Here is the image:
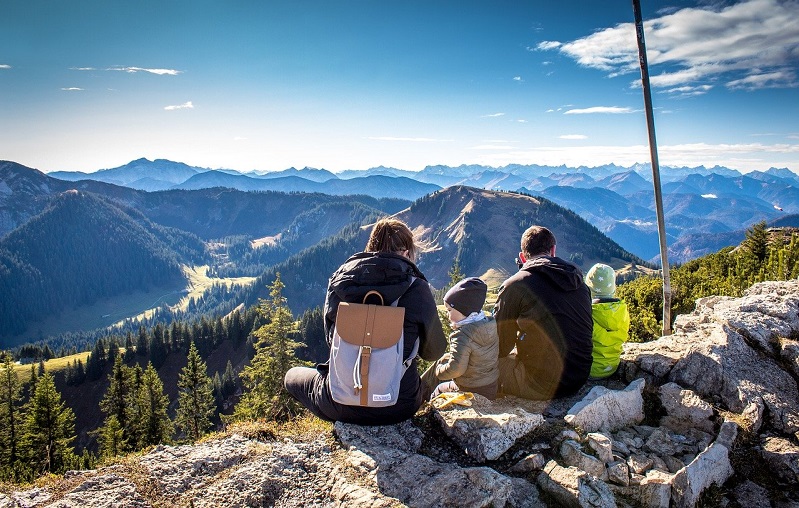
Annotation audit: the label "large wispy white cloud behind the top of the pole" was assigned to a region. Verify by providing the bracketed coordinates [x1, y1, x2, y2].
[536, 0, 799, 93]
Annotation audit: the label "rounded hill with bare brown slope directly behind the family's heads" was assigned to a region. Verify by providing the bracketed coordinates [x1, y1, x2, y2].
[231, 186, 647, 313]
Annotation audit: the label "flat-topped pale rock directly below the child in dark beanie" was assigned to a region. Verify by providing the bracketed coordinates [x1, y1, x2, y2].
[435, 394, 544, 462]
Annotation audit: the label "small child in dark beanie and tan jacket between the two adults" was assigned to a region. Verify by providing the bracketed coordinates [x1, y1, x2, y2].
[422, 277, 499, 400]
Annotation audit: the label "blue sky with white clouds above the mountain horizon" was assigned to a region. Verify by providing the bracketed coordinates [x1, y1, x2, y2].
[0, 0, 799, 172]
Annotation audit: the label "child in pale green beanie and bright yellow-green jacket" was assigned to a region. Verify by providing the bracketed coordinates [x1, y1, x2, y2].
[585, 263, 630, 379]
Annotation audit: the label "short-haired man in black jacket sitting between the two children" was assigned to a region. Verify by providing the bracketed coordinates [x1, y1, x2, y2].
[494, 226, 593, 400]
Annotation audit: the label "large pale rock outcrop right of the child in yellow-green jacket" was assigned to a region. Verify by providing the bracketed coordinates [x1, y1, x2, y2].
[622, 280, 799, 434]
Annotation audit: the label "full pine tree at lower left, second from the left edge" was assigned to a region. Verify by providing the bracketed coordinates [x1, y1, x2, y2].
[22, 372, 75, 473]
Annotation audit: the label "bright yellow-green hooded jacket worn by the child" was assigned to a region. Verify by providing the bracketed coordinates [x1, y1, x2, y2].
[591, 298, 630, 378]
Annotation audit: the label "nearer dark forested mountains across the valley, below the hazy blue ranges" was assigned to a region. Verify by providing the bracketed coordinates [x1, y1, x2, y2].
[0, 162, 645, 342]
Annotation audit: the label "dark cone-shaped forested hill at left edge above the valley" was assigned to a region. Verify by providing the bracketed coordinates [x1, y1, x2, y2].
[0, 190, 207, 334]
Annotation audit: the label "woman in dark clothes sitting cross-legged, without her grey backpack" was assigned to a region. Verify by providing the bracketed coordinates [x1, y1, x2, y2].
[284, 219, 447, 425]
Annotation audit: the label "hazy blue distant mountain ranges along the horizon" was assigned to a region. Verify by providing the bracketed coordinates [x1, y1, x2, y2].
[43, 159, 799, 263]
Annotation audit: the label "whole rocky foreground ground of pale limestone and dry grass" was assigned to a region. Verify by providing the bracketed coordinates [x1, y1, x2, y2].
[0, 280, 799, 508]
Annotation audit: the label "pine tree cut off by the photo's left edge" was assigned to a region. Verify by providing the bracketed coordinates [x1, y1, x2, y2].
[0, 354, 22, 480]
